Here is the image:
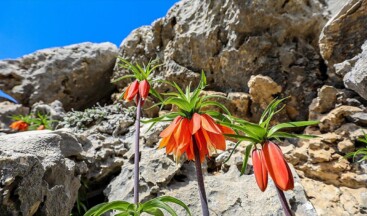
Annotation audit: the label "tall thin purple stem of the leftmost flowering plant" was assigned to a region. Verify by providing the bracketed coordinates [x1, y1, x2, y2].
[134, 94, 141, 204]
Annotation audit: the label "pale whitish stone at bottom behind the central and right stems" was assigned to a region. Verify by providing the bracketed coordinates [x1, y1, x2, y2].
[162, 164, 316, 216]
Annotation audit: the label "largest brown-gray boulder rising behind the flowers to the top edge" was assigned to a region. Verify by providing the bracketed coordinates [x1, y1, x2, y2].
[114, 0, 326, 120]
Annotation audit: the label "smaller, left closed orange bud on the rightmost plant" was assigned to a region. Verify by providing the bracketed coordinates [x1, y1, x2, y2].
[252, 149, 268, 192]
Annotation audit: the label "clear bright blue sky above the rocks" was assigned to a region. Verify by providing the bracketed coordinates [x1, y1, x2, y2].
[0, 0, 178, 59]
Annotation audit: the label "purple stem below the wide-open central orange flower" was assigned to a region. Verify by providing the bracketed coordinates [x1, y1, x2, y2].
[192, 137, 209, 216]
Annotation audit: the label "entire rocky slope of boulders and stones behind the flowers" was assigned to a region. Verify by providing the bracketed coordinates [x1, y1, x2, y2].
[0, 0, 367, 216]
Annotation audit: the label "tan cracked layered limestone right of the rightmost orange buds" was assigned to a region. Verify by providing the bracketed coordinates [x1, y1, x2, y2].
[286, 130, 367, 189]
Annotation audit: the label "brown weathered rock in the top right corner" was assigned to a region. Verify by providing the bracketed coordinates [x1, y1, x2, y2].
[319, 0, 367, 81]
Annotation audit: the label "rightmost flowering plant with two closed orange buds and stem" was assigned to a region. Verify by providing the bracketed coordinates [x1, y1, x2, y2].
[222, 98, 318, 216]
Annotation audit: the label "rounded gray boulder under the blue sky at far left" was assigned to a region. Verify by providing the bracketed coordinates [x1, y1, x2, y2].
[0, 43, 118, 110]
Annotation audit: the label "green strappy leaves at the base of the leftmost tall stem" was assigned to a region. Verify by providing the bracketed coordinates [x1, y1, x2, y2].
[84, 196, 191, 216]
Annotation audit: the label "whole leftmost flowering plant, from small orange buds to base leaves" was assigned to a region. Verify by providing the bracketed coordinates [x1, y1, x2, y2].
[84, 58, 191, 216]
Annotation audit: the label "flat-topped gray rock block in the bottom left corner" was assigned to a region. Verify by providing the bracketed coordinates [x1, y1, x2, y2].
[0, 131, 83, 216]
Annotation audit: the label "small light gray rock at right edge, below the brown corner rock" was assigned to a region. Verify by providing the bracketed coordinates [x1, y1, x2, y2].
[343, 41, 367, 100]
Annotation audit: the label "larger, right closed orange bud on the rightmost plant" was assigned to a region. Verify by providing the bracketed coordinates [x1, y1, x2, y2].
[263, 141, 294, 191]
